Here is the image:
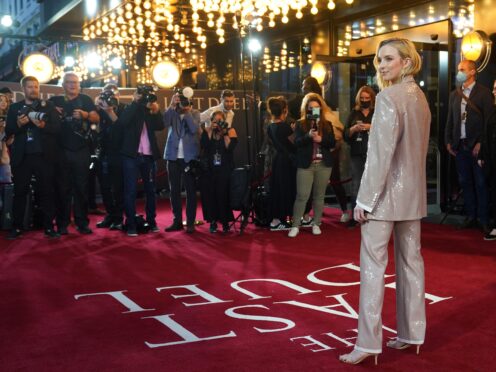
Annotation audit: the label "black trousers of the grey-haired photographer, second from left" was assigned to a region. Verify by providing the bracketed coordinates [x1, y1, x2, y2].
[56, 147, 90, 228]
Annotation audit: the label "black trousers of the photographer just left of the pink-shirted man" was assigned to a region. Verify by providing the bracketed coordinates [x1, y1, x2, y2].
[97, 155, 124, 223]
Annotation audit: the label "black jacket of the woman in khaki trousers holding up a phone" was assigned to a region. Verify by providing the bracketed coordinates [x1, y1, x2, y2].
[295, 121, 336, 168]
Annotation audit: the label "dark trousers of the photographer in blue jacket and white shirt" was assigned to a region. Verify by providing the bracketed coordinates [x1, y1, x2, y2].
[167, 159, 196, 225]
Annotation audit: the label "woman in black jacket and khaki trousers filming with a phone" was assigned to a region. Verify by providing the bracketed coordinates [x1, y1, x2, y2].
[288, 93, 336, 238]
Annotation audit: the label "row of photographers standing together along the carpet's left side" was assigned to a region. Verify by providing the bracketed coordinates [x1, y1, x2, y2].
[0, 72, 237, 240]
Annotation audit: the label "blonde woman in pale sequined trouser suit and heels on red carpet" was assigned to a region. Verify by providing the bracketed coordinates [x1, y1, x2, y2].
[340, 38, 431, 364]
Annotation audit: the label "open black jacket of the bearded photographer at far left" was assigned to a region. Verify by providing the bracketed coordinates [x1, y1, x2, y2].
[5, 100, 60, 168]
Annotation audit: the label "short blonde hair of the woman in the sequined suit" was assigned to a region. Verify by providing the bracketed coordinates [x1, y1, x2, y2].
[374, 38, 422, 89]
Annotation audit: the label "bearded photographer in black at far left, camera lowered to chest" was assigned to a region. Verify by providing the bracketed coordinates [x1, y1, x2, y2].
[5, 76, 60, 239]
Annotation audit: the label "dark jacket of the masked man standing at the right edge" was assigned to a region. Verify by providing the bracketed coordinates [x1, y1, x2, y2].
[445, 83, 493, 150]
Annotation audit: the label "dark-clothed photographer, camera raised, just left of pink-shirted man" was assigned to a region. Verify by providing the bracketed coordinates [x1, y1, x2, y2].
[96, 84, 125, 230]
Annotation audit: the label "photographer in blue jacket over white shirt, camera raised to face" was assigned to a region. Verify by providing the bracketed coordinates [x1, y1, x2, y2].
[164, 91, 200, 234]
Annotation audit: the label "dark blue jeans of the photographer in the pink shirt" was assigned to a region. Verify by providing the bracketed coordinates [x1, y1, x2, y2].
[122, 155, 157, 229]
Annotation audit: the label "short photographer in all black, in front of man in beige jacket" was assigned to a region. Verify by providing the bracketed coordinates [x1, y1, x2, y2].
[200, 111, 238, 233]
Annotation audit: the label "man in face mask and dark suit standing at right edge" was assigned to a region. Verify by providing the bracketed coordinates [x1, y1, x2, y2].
[445, 60, 493, 233]
